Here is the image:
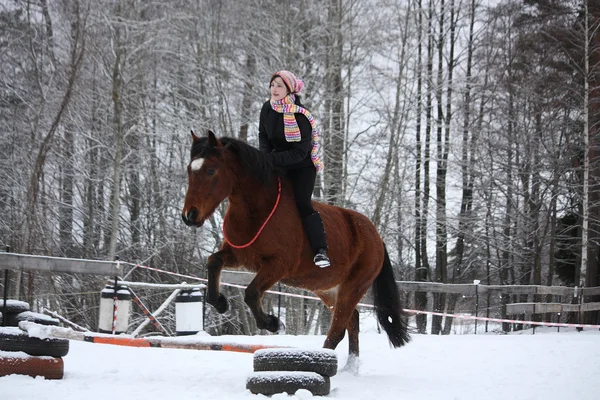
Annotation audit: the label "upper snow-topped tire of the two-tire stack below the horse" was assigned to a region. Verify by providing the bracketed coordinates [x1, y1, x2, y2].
[254, 349, 338, 377]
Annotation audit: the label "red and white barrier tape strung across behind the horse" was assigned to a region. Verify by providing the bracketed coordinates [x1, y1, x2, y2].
[122, 262, 600, 329]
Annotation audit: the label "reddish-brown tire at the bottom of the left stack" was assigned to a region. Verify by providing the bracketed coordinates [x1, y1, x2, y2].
[0, 355, 65, 379]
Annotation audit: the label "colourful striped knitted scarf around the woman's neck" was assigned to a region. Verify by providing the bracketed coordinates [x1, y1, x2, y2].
[271, 94, 323, 171]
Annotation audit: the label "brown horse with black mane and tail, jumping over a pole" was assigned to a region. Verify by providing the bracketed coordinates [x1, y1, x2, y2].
[182, 131, 409, 357]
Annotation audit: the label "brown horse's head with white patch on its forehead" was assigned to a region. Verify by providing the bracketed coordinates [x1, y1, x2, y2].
[181, 131, 233, 227]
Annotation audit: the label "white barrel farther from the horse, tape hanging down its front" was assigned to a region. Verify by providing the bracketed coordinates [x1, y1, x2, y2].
[98, 285, 131, 334]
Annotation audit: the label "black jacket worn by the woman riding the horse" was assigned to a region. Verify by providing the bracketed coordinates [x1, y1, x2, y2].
[258, 99, 313, 169]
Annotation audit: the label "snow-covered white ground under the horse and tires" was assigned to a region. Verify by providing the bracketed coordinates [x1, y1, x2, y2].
[0, 328, 600, 400]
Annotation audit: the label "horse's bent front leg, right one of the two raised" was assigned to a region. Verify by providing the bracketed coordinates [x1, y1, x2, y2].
[244, 268, 284, 332]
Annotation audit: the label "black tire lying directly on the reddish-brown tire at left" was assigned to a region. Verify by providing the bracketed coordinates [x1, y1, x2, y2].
[0, 328, 69, 357]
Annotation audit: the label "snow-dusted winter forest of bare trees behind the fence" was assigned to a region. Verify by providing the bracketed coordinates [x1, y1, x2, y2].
[0, 0, 600, 333]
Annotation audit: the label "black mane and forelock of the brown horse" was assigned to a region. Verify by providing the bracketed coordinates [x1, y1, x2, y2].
[191, 137, 281, 184]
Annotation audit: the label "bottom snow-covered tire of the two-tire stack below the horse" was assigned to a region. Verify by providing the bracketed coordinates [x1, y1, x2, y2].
[246, 371, 331, 396]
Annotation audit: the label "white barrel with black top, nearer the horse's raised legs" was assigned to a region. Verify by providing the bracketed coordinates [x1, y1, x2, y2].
[175, 288, 204, 336]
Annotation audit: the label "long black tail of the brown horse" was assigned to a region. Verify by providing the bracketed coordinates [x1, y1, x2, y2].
[372, 245, 410, 347]
